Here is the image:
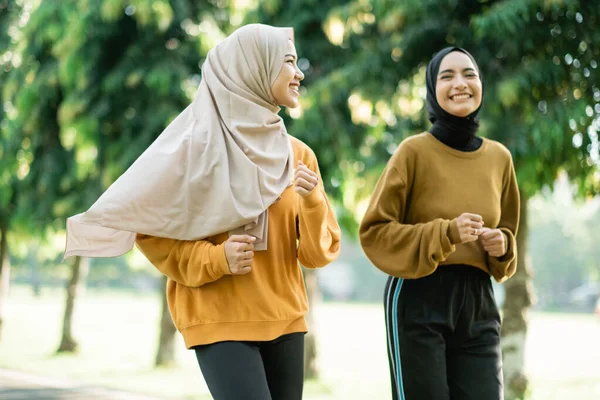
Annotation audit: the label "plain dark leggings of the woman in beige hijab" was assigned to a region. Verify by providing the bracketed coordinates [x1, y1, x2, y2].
[194, 333, 304, 400]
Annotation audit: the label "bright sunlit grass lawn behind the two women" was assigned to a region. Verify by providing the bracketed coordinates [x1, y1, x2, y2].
[0, 288, 600, 400]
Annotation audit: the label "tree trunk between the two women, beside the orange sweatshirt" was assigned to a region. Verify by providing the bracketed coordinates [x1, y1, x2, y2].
[304, 268, 321, 379]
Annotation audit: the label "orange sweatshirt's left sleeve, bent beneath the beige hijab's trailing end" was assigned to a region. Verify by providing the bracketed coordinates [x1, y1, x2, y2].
[136, 234, 231, 287]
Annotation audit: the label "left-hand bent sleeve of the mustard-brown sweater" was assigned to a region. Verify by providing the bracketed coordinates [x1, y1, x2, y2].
[359, 144, 460, 279]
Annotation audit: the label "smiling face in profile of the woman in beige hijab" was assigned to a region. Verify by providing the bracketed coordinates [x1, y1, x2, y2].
[271, 40, 304, 108]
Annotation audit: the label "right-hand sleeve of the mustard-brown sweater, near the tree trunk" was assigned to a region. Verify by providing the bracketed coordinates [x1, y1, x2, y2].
[487, 155, 520, 282]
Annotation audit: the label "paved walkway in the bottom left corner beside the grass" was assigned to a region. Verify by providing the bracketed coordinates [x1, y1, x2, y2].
[0, 369, 160, 400]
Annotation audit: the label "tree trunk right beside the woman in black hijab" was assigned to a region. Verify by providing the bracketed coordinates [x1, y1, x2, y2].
[501, 191, 534, 400]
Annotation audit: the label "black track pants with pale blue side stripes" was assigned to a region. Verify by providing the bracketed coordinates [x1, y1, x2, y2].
[385, 265, 503, 400]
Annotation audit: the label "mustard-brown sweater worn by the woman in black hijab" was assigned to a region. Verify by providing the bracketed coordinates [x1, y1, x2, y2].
[360, 132, 519, 282]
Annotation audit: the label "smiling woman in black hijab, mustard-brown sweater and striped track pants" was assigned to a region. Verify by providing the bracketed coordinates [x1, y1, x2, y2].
[360, 47, 519, 400]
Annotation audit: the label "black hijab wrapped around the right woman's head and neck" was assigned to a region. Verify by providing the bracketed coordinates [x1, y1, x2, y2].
[426, 47, 483, 151]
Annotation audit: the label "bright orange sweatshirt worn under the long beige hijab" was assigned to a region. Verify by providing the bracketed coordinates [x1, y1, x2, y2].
[136, 137, 341, 348]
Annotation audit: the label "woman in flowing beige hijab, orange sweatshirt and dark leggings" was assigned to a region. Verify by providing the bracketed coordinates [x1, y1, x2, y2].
[65, 24, 340, 400]
